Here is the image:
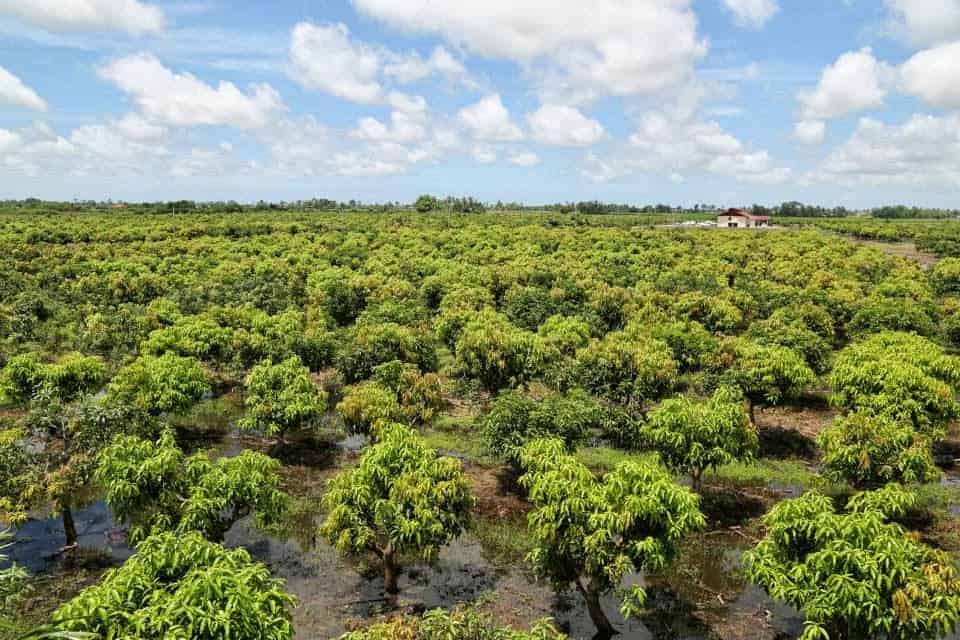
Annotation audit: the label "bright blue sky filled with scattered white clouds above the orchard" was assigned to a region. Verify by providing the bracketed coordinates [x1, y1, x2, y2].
[0, 0, 960, 208]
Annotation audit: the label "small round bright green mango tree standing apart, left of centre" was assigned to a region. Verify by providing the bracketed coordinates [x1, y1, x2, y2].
[240, 356, 327, 438]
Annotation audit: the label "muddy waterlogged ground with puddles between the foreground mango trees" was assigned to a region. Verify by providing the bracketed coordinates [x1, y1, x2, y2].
[5, 414, 960, 640]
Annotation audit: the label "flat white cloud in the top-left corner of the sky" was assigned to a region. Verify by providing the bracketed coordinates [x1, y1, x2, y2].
[0, 0, 164, 36]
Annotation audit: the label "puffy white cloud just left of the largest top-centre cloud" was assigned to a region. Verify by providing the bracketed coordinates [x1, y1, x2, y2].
[290, 22, 383, 104]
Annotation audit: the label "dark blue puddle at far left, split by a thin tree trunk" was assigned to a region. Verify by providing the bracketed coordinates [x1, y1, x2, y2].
[5, 501, 133, 573]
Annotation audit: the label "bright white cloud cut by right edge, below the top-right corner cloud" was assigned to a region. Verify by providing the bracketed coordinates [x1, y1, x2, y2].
[900, 42, 960, 109]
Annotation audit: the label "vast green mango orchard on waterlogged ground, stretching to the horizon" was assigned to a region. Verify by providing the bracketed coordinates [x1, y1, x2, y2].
[0, 211, 960, 640]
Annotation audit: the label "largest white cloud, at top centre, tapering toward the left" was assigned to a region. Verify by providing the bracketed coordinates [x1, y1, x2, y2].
[353, 0, 707, 100]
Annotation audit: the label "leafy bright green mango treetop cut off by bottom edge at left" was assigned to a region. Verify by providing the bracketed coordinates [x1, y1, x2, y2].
[51, 532, 296, 640]
